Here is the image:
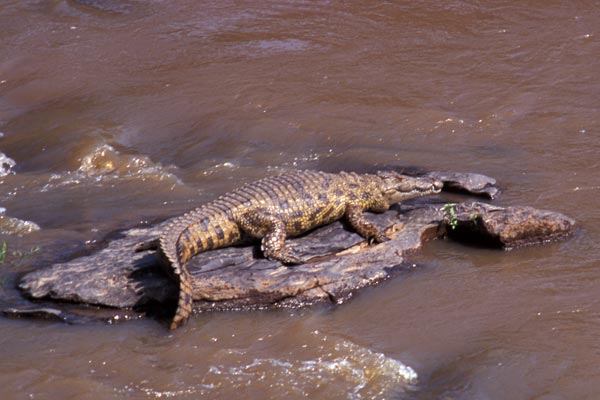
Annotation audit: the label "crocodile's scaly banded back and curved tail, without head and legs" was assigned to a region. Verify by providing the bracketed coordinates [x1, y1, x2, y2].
[160, 171, 380, 329]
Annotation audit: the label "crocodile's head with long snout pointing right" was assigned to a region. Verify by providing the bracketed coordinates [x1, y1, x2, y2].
[377, 171, 444, 204]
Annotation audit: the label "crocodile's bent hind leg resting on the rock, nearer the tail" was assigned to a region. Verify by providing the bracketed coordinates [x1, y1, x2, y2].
[236, 211, 304, 265]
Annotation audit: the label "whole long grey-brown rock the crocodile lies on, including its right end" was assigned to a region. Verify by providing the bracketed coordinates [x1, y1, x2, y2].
[11, 174, 575, 324]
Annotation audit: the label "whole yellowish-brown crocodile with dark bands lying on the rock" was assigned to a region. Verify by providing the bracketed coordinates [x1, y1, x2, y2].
[137, 170, 443, 329]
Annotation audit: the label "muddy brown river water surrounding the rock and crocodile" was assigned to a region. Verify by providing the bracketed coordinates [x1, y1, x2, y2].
[0, 0, 600, 400]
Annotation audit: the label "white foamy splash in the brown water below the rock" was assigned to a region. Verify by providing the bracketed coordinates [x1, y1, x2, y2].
[202, 340, 417, 400]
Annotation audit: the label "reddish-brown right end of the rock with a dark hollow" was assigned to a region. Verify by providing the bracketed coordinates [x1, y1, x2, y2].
[440, 203, 575, 249]
